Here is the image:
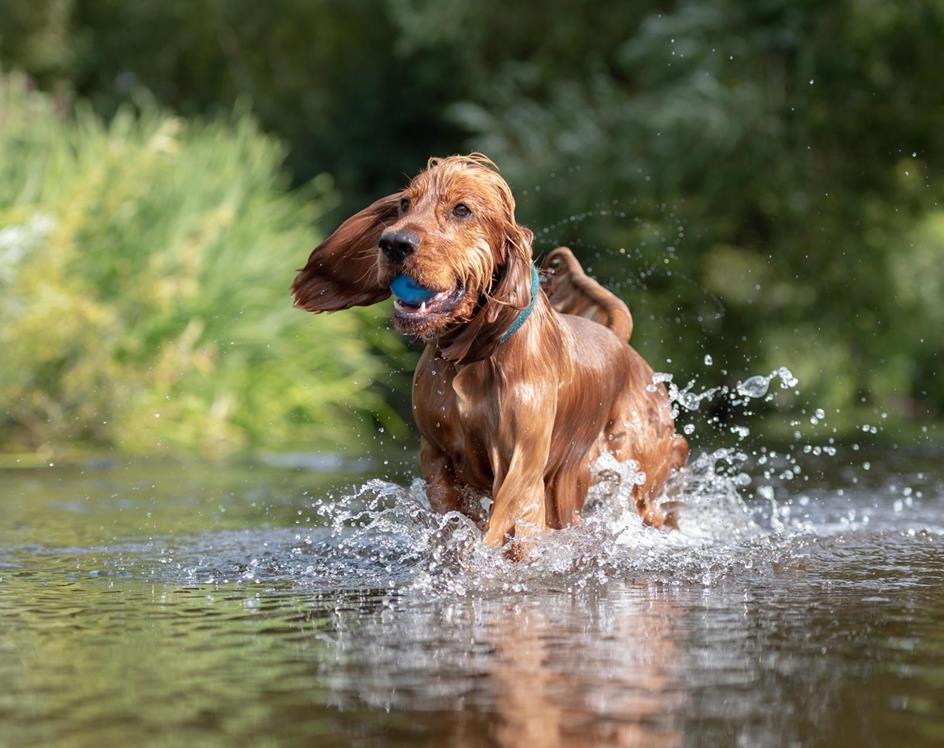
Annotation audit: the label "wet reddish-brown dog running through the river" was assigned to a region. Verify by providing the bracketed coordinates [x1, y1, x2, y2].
[292, 154, 688, 546]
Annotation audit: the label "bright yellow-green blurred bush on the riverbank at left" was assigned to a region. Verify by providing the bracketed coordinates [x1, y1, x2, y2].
[0, 76, 395, 453]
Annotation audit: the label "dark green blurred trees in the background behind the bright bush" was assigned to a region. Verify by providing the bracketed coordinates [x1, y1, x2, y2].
[0, 0, 944, 450]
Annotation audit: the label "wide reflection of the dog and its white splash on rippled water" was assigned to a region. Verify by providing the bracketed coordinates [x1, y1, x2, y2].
[320, 587, 682, 748]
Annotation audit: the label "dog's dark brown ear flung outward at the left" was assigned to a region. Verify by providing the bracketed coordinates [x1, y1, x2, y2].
[292, 193, 400, 312]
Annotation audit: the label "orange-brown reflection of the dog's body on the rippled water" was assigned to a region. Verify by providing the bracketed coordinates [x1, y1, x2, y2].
[488, 597, 680, 746]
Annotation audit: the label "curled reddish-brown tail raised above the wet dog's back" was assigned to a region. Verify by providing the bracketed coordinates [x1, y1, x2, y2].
[542, 247, 633, 343]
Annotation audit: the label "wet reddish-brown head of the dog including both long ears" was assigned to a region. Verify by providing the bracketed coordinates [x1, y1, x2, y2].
[292, 154, 532, 360]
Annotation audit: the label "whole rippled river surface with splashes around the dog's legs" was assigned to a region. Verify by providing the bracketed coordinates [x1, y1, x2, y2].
[0, 444, 944, 746]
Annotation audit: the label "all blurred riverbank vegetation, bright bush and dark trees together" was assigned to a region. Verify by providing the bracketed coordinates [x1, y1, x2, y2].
[0, 0, 944, 453]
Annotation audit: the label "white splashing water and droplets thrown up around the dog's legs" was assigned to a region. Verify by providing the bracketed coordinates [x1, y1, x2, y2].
[282, 360, 892, 595]
